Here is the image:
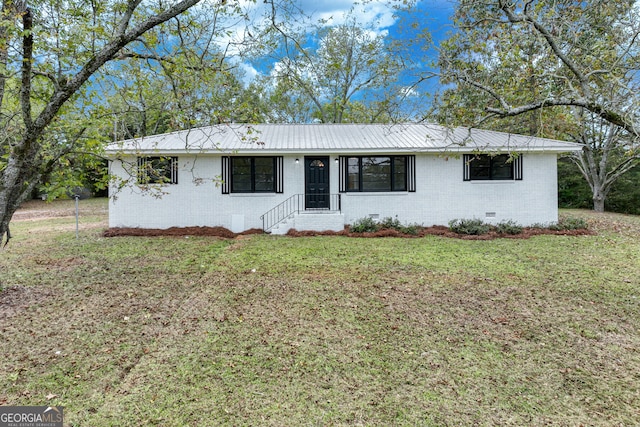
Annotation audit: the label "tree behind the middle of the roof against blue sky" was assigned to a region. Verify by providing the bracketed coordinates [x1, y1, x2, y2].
[252, 13, 405, 123]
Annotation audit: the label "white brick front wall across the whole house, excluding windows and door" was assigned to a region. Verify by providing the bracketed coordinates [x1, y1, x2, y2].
[109, 153, 558, 232]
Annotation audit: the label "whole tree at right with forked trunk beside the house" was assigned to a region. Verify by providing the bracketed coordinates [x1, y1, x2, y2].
[436, 0, 640, 210]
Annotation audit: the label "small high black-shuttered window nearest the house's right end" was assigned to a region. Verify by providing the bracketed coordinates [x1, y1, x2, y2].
[463, 154, 522, 181]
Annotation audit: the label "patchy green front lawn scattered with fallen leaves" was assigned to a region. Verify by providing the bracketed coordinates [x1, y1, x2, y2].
[0, 200, 640, 426]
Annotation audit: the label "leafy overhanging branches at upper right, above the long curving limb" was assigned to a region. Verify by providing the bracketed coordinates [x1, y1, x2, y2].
[440, 0, 640, 138]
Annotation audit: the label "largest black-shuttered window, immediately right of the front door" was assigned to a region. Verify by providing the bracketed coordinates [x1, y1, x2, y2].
[340, 156, 415, 192]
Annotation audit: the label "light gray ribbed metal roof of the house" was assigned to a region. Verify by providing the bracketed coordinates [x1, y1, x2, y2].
[107, 124, 582, 154]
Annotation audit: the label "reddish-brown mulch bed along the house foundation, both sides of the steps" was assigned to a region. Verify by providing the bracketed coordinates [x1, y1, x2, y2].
[102, 226, 595, 240]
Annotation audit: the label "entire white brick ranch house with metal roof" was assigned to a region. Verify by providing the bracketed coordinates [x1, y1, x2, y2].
[107, 124, 581, 233]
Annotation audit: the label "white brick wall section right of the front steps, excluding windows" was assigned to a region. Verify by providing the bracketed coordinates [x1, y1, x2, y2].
[342, 154, 558, 226]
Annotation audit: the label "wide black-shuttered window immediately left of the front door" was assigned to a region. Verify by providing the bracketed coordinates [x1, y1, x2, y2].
[222, 156, 282, 194]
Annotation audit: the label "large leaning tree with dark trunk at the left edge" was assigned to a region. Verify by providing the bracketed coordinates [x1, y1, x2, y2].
[0, 0, 241, 242]
